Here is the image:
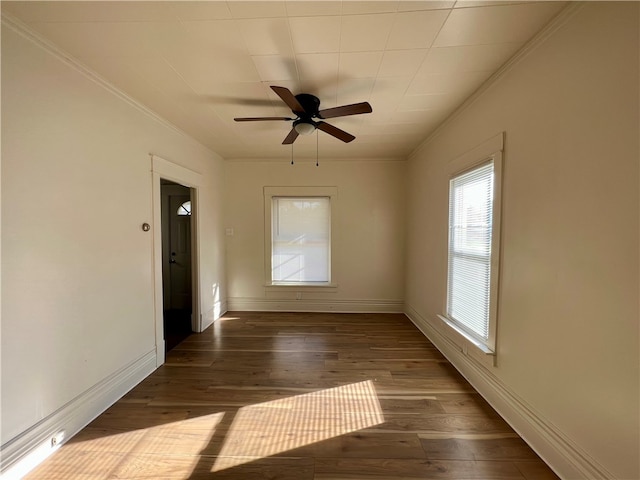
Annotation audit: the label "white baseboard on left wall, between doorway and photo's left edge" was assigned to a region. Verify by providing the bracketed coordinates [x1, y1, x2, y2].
[0, 349, 156, 480]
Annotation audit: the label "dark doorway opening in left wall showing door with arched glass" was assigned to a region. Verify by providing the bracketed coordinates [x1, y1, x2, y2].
[160, 179, 194, 353]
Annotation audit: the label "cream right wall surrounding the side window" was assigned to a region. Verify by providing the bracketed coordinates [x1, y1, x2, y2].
[406, 2, 640, 479]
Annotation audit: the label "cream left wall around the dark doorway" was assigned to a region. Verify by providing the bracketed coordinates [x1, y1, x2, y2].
[2, 20, 224, 460]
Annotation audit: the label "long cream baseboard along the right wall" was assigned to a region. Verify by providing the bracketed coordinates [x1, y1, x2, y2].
[405, 305, 615, 480]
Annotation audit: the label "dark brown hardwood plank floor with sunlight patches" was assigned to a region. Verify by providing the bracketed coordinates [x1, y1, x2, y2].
[27, 312, 558, 480]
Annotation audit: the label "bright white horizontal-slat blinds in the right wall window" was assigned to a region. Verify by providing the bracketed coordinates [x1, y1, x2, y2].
[447, 161, 494, 341]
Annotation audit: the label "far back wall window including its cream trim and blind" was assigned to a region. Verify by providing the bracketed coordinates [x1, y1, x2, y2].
[265, 187, 337, 289]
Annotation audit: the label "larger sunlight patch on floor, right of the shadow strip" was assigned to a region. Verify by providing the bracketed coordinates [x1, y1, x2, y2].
[211, 380, 384, 472]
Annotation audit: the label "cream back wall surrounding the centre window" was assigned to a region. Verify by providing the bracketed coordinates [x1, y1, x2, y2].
[225, 158, 405, 311]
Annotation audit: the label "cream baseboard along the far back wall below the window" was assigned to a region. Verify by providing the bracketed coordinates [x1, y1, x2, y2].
[227, 297, 404, 313]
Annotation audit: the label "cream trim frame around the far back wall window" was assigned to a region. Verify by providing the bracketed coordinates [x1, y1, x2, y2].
[264, 186, 338, 292]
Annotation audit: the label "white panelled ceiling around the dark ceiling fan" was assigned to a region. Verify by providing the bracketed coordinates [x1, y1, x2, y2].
[2, 0, 565, 159]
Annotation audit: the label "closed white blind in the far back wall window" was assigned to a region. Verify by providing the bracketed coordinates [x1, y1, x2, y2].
[271, 197, 331, 283]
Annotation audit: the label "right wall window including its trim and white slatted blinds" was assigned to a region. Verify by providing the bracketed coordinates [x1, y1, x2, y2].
[441, 135, 503, 355]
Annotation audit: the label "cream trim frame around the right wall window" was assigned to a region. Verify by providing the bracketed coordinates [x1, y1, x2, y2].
[438, 132, 504, 364]
